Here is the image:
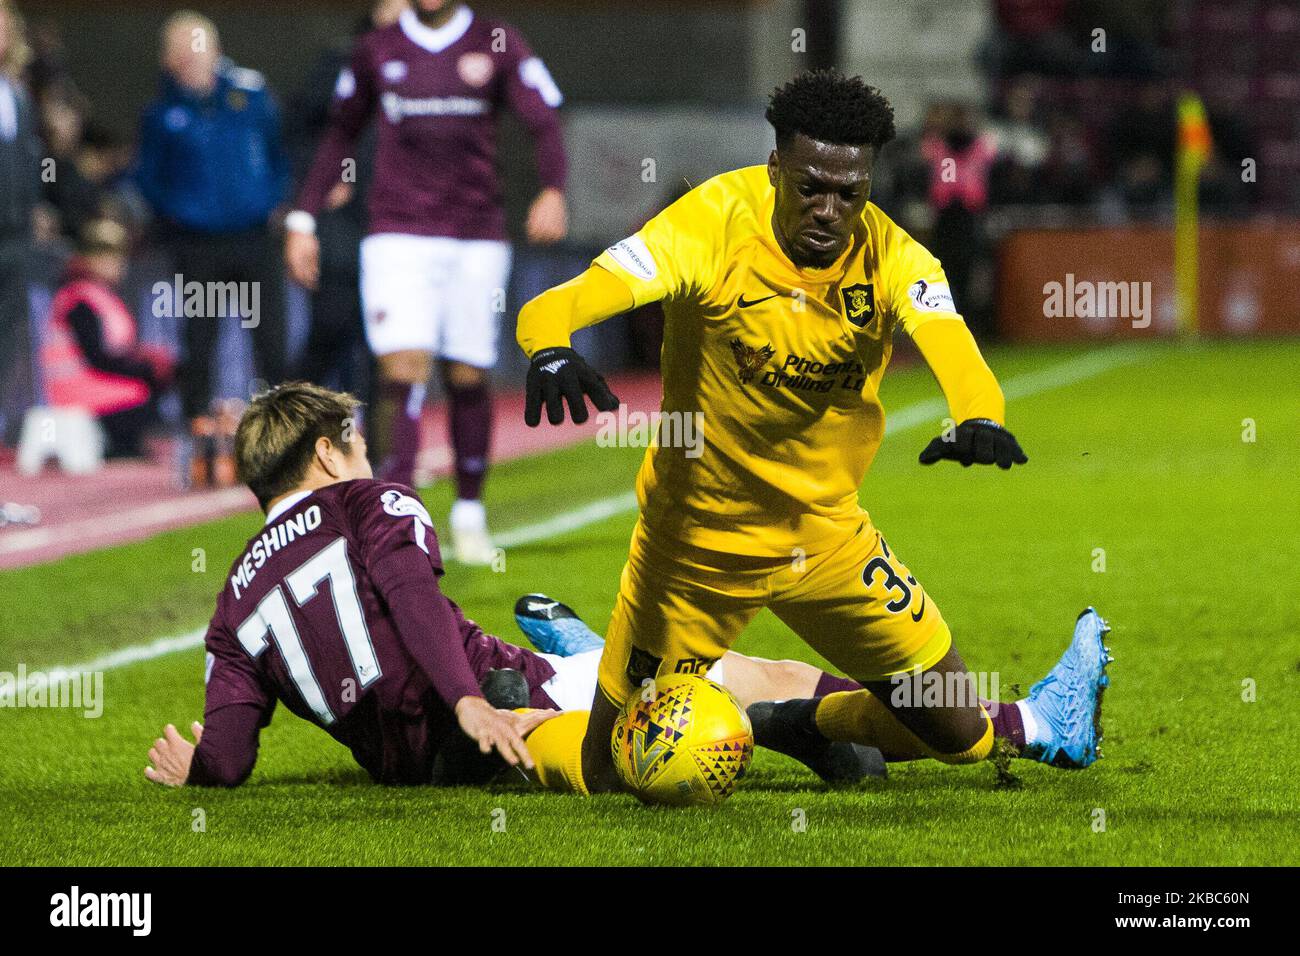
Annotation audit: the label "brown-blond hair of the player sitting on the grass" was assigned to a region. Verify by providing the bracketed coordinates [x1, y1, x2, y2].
[235, 381, 361, 507]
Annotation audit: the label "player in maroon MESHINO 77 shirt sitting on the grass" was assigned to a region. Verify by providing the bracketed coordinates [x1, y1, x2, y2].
[146, 382, 879, 790]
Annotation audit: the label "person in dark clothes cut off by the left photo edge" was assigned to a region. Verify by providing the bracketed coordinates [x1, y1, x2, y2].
[0, 0, 42, 442]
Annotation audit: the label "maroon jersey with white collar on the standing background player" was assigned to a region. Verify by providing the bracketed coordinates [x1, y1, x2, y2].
[298, 7, 566, 239]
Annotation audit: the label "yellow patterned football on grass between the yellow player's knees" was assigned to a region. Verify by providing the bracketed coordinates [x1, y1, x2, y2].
[610, 674, 754, 806]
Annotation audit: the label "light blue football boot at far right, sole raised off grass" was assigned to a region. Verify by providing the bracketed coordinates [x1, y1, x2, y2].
[1022, 607, 1114, 770]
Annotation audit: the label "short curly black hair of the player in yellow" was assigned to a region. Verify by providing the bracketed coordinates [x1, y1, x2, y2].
[767, 70, 894, 152]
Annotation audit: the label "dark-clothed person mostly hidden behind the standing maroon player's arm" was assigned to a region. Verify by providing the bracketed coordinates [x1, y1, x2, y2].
[285, 0, 407, 407]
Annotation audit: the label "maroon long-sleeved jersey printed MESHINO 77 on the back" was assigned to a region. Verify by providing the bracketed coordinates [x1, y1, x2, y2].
[190, 480, 555, 786]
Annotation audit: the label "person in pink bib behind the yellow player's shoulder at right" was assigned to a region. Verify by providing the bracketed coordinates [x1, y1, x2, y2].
[920, 103, 997, 333]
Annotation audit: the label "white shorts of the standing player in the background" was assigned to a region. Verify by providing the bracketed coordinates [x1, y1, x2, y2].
[361, 233, 511, 368]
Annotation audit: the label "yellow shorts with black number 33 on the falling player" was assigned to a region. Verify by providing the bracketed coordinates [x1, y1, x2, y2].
[599, 515, 953, 705]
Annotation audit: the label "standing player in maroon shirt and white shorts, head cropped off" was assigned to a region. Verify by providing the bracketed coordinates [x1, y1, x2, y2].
[285, 0, 568, 564]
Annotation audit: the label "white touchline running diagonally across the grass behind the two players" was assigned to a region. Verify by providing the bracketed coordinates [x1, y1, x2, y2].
[17, 346, 1147, 693]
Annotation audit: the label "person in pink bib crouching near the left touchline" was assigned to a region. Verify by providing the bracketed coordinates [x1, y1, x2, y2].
[40, 220, 174, 458]
